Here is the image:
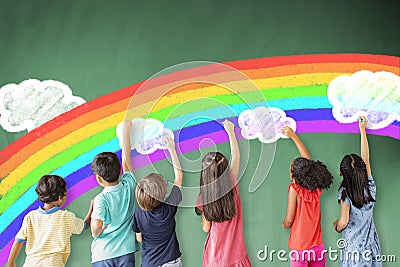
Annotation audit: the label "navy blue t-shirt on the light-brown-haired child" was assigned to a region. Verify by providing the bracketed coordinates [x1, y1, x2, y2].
[133, 186, 182, 267]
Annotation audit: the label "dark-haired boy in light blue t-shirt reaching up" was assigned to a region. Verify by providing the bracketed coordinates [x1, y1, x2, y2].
[91, 121, 138, 267]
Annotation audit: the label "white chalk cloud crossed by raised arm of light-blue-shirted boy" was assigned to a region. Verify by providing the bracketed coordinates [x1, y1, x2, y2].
[116, 118, 174, 154]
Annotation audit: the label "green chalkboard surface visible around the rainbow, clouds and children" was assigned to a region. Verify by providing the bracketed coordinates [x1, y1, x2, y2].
[0, 0, 400, 267]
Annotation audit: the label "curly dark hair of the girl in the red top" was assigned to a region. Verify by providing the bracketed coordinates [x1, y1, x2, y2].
[290, 157, 333, 191]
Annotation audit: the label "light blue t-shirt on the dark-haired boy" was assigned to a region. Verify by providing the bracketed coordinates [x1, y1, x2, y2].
[92, 172, 139, 263]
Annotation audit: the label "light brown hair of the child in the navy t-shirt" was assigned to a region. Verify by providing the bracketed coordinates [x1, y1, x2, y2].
[135, 173, 167, 211]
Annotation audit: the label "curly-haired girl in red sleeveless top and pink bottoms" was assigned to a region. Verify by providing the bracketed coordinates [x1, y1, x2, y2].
[282, 126, 333, 267]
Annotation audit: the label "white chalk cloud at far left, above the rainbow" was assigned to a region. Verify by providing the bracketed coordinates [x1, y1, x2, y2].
[0, 79, 86, 132]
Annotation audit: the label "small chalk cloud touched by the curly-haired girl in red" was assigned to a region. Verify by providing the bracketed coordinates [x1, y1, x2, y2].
[238, 107, 296, 143]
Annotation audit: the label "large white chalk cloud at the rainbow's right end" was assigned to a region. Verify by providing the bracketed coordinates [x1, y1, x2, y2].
[328, 70, 400, 129]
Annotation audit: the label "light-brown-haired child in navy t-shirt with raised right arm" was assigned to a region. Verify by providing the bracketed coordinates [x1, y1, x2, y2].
[133, 138, 183, 267]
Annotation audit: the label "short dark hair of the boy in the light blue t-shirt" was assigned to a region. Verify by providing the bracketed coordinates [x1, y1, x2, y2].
[91, 152, 121, 183]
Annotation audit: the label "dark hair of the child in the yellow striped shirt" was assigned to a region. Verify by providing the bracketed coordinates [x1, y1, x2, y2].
[35, 175, 67, 203]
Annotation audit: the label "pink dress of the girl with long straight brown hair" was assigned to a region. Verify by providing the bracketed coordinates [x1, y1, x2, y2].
[198, 174, 251, 267]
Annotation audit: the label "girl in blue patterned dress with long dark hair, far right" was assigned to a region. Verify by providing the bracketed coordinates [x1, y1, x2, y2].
[333, 117, 382, 267]
